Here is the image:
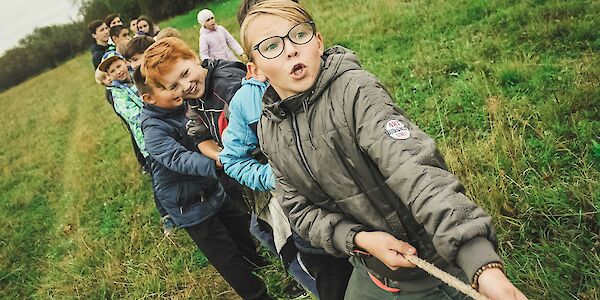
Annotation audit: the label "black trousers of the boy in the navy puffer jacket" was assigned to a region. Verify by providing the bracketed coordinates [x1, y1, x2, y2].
[185, 198, 270, 299]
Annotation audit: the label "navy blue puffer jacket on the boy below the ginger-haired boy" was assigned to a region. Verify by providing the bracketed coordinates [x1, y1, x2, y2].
[142, 103, 226, 227]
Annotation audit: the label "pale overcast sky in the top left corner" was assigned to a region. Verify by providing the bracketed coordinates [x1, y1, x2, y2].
[0, 0, 78, 55]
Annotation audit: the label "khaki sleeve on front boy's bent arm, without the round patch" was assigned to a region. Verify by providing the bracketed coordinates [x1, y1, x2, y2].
[273, 163, 362, 257]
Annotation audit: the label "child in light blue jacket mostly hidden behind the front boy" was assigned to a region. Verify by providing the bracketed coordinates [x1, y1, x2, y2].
[219, 0, 360, 299]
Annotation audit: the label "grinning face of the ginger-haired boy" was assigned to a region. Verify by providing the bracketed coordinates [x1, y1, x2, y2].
[160, 59, 208, 99]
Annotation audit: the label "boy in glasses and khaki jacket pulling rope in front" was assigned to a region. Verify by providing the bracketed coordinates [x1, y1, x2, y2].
[241, 0, 526, 299]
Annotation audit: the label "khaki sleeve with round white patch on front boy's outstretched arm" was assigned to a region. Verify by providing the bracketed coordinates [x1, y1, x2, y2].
[344, 78, 500, 278]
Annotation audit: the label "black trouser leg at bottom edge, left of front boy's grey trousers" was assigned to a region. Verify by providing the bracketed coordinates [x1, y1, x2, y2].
[300, 252, 353, 300]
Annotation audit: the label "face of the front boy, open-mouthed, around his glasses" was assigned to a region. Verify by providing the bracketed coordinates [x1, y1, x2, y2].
[247, 14, 323, 99]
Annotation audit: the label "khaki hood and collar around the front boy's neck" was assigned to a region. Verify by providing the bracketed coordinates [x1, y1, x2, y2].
[263, 46, 361, 122]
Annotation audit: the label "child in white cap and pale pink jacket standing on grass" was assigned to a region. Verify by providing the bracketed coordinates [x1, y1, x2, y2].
[198, 9, 247, 61]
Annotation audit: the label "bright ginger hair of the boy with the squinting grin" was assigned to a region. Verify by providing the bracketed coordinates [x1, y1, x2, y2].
[142, 37, 198, 89]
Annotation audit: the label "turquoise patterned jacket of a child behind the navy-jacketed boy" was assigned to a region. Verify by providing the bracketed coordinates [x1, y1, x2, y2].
[107, 81, 148, 158]
